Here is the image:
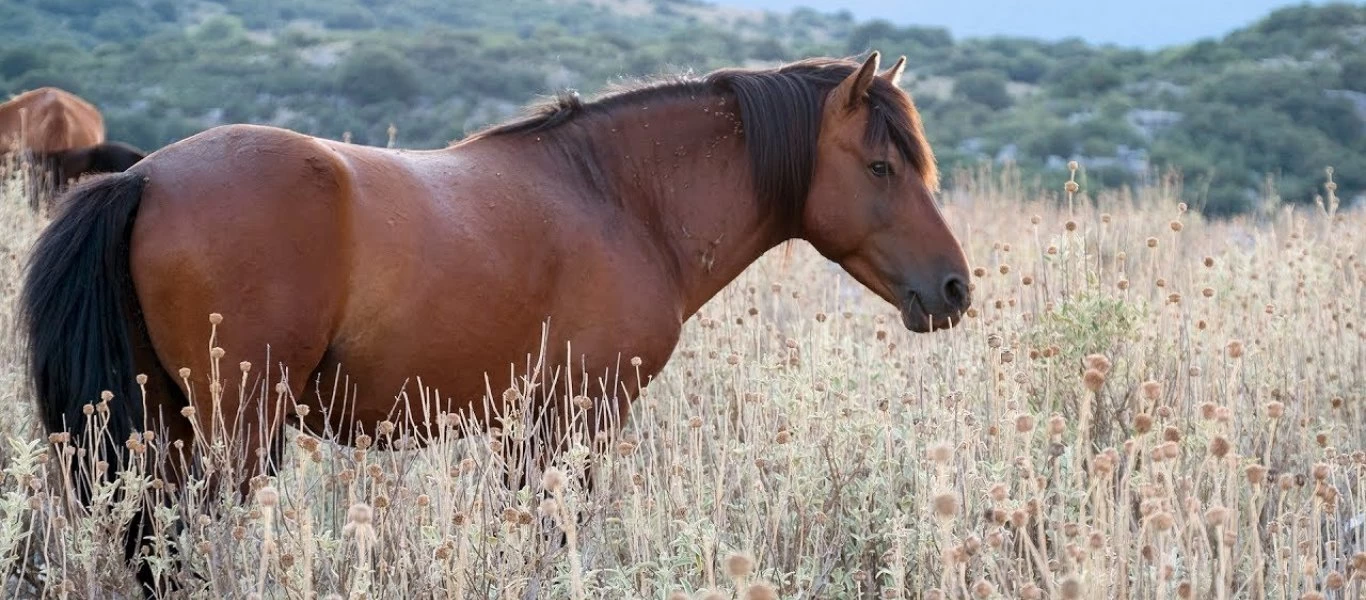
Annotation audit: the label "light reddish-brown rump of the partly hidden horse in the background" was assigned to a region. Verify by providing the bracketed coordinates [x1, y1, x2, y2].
[0, 87, 104, 156]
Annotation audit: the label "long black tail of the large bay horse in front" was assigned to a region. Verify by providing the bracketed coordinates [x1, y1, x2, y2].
[18, 172, 148, 467]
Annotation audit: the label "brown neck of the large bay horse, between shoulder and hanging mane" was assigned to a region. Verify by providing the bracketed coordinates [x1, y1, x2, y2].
[590, 94, 791, 320]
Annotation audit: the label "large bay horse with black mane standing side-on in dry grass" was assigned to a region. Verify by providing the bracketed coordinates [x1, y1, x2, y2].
[22, 53, 970, 593]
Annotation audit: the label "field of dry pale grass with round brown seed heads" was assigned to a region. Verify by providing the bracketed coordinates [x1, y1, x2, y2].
[0, 157, 1366, 599]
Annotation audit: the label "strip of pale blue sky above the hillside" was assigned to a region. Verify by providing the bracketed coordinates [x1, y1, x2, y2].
[712, 0, 1344, 49]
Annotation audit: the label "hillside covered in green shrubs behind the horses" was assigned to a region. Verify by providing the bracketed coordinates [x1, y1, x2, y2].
[0, 0, 1366, 215]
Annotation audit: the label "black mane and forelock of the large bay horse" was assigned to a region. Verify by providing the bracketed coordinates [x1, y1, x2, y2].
[466, 57, 938, 223]
